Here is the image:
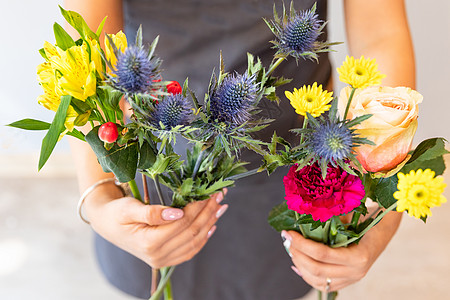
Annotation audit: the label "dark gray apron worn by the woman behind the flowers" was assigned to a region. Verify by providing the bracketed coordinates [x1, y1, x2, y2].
[95, 0, 331, 300]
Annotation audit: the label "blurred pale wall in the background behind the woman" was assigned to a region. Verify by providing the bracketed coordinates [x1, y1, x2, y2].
[0, 0, 450, 170]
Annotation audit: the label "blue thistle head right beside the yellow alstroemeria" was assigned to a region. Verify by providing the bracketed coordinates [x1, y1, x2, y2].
[112, 46, 158, 94]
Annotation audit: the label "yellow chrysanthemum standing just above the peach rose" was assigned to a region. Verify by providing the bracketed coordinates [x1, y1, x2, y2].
[337, 56, 386, 89]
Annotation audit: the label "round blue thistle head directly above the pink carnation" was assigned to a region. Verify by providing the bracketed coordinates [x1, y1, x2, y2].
[309, 122, 353, 162]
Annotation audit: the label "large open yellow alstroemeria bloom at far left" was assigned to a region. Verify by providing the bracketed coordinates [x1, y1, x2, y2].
[44, 42, 97, 101]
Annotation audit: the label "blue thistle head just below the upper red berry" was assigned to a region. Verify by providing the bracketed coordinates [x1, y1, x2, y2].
[150, 94, 192, 130]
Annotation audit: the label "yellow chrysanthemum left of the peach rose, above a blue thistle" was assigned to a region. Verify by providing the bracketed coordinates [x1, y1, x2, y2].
[284, 82, 333, 118]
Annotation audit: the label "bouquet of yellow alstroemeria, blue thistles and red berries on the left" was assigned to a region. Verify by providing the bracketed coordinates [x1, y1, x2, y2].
[10, 2, 340, 299]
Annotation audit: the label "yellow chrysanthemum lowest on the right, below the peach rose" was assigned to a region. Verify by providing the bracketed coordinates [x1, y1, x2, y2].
[394, 169, 447, 219]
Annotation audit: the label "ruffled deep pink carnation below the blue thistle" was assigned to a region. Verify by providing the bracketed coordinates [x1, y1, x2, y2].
[283, 164, 365, 222]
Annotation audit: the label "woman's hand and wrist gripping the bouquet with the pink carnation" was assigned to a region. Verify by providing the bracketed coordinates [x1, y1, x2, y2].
[282, 212, 401, 291]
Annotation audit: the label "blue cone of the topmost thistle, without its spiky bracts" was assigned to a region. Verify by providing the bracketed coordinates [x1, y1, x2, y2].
[279, 10, 323, 54]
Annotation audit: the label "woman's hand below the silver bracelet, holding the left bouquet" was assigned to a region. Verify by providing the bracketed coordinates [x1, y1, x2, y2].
[84, 185, 228, 269]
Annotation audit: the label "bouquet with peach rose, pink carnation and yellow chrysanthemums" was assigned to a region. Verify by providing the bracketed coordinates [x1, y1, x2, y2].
[265, 56, 448, 299]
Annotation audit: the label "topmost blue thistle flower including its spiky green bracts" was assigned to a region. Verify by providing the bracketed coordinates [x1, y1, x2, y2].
[264, 2, 336, 61]
